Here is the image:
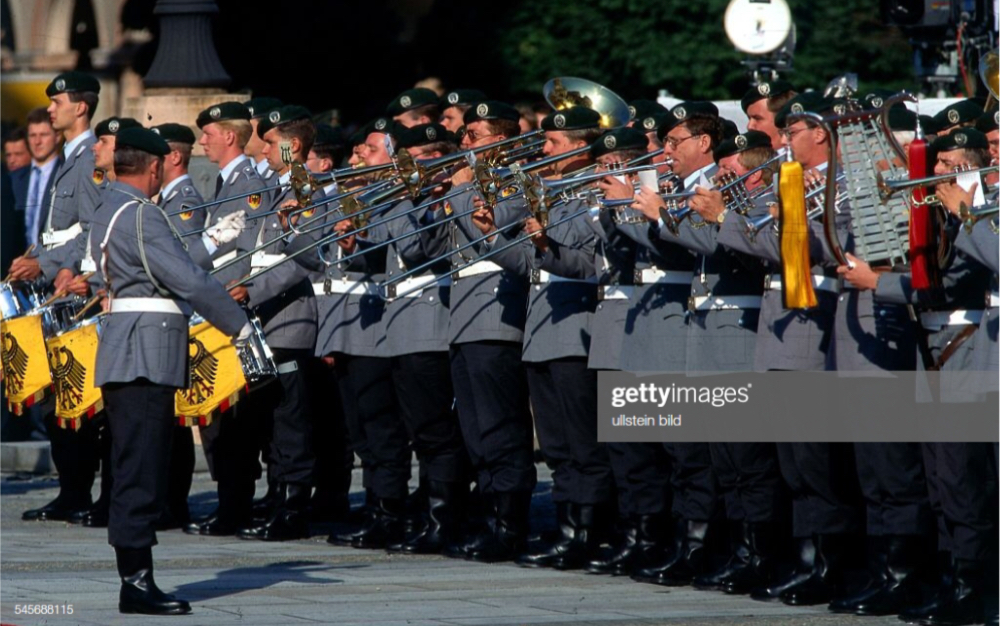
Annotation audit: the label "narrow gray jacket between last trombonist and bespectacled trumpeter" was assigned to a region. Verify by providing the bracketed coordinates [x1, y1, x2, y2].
[583, 205, 638, 370]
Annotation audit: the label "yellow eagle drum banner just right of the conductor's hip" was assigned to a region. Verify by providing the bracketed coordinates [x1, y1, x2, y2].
[174, 322, 247, 426]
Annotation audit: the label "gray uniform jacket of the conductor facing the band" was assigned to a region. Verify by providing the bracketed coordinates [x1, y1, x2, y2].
[89, 178, 246, 388]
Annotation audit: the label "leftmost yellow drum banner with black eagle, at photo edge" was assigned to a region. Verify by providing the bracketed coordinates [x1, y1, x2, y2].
[0, 315, 52, 415]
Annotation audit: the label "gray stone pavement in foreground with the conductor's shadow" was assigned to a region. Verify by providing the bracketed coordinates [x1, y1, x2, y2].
[0, 466, 901, 626]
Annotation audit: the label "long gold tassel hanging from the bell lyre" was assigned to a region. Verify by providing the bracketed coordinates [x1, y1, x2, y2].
[779, 161, 819, 309]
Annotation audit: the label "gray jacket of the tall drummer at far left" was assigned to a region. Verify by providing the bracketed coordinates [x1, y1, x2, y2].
[38, 131, 108, 280]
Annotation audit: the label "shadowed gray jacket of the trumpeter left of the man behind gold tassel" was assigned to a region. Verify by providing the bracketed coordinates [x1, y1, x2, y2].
[661, 196, 767, 372]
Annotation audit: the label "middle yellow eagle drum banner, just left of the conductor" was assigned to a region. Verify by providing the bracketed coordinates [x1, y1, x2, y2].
[46, 318, 104, 430]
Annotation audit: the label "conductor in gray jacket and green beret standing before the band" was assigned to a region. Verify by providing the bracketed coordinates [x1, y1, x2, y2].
[90, 128, 250, 615]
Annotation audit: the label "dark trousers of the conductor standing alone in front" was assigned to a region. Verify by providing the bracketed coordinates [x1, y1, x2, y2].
[102, 378, 177, 548]
